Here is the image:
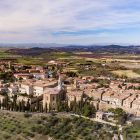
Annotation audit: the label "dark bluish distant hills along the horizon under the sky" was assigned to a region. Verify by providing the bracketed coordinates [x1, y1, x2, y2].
[0, 43, 140, 55]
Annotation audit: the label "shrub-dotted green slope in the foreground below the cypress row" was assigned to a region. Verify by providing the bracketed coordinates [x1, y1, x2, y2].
[0, 111, 117, 140]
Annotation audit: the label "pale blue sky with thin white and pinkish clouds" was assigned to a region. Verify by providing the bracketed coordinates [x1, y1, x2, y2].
[0, 0, 140, 45]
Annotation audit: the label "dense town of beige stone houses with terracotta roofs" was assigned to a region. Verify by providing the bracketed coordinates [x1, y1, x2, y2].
[0, 61, 140, 116]
